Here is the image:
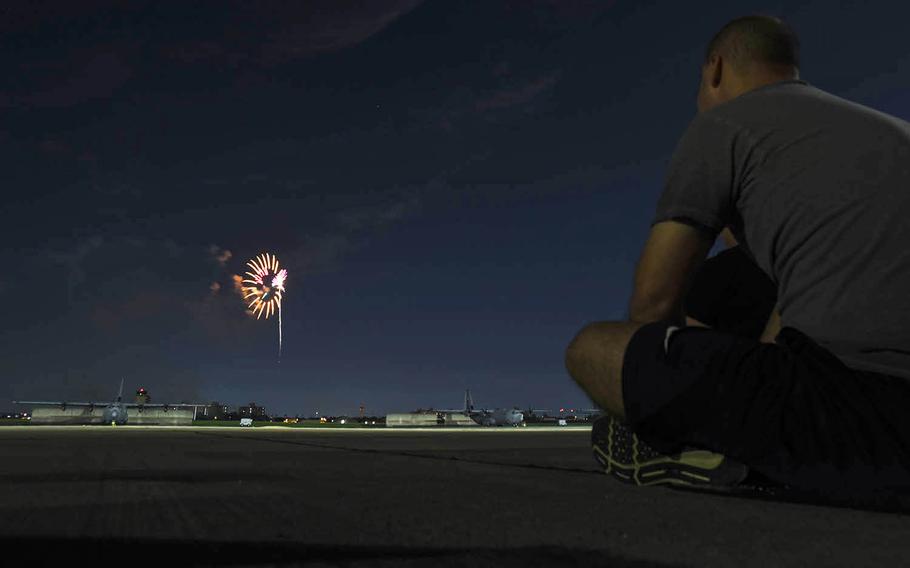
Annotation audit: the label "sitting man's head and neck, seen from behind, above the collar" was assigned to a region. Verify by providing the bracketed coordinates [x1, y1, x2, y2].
[698, 16, 799, 112]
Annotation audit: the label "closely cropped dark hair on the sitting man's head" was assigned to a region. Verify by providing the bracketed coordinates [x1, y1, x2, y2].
[705, 14, 799, 70]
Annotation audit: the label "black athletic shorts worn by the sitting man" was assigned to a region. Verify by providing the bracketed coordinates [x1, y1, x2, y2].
[622, 322, 910, 495]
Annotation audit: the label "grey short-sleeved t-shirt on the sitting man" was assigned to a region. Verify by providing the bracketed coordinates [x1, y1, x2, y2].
[653, 80, 910, 378]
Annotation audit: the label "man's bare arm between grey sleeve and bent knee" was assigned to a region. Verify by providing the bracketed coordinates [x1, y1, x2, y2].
[629, 221, 714, 323]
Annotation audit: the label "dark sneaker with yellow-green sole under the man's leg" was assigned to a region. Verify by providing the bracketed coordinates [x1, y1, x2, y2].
[591, 416, 749, 488]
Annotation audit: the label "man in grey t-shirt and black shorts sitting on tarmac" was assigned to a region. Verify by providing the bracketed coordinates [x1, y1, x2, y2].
[566, 16, 910, 502]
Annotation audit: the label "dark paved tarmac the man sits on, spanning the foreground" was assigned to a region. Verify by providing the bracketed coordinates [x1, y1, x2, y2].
[0, 426, 910, 567]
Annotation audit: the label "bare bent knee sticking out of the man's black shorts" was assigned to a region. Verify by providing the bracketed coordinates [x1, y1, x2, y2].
[566, 321, 644, 418]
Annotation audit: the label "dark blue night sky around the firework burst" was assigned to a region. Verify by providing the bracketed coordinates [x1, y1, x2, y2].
[0, 0, 910, 415]
